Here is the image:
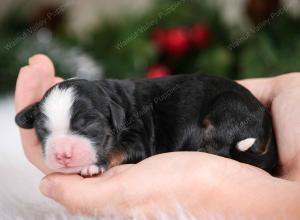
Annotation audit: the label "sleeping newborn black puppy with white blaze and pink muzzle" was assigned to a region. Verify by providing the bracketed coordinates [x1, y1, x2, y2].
[16, 75, 277, 176]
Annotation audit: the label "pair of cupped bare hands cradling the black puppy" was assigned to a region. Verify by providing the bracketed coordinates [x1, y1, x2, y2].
[16, 55, 300, 219]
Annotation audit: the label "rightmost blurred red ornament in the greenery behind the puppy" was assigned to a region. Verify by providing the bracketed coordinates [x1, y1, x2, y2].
[189, 24, 212, 48]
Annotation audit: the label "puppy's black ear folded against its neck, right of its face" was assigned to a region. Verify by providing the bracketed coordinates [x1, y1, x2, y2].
[110, 100, 125, 130]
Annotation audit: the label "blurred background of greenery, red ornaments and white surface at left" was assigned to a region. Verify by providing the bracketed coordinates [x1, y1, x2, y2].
[0, 0, 300, 219]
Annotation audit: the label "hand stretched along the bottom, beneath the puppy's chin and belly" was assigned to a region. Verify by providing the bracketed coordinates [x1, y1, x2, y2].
[40, 152, 300, 219]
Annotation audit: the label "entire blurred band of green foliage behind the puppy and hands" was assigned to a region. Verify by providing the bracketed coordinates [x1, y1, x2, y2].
[0, 0, 300, 92]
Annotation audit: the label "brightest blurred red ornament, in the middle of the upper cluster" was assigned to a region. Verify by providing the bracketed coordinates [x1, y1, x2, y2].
[165, 28, 189, 56]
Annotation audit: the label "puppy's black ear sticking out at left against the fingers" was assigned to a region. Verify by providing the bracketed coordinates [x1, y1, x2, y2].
[15, 103, 38, 129]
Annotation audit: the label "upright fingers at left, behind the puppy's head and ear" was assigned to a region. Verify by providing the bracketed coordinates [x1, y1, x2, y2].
[15, 55, 62, 173]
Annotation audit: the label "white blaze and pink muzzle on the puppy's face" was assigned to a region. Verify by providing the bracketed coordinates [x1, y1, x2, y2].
[41, 86, 97, 173]
